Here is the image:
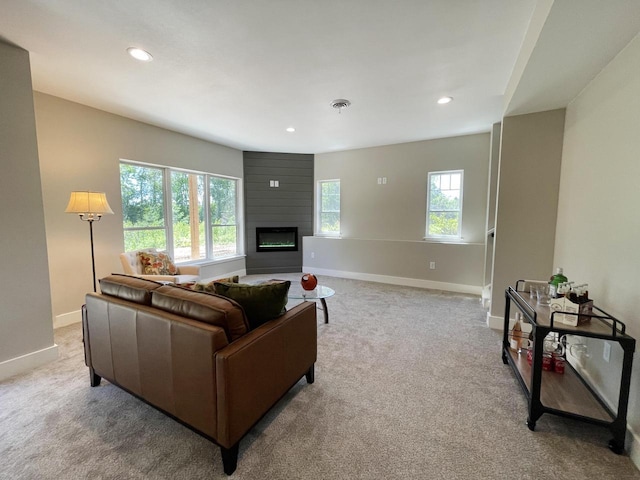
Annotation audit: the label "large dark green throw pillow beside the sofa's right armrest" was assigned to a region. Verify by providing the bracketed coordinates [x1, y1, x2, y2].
[214, 280, 291, 330]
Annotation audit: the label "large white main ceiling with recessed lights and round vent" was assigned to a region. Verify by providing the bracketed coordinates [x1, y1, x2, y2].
[0, 0, 535, 153]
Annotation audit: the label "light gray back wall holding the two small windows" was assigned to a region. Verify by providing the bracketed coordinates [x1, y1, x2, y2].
[304, 133, 489, 294]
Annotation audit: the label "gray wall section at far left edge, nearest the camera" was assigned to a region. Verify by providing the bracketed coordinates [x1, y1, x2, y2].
[0, 42, 57, 379]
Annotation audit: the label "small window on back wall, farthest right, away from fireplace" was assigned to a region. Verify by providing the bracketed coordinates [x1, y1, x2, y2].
[427, 170, 463, 239]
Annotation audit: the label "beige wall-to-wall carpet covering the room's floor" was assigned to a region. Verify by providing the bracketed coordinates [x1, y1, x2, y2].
[0, 274, 640, 480]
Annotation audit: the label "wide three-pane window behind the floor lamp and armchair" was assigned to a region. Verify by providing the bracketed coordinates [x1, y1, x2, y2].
[120, 162, 241, 262]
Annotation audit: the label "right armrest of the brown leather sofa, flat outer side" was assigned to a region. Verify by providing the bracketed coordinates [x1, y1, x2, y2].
[216, 302, 318, 448]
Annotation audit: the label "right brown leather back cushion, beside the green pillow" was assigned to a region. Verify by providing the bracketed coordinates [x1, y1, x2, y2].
[151, 285, 249, 342]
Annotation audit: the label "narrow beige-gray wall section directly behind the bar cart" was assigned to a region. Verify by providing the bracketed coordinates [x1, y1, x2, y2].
[490, 109, 565, 327]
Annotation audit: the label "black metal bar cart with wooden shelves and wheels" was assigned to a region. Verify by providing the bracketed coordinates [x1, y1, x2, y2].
[502, 280, 636, 454]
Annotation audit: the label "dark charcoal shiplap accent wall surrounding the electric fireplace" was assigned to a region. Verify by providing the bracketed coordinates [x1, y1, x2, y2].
[244, 152, 314, 274]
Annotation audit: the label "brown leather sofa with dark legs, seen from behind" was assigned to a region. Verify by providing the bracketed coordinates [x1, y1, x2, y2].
[82, 275, 317, 475]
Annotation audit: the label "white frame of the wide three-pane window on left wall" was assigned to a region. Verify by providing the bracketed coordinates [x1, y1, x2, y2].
[120, 159, 244, 265]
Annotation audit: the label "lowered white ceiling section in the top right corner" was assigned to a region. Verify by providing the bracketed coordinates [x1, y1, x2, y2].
[504, 0, 640, 115]
